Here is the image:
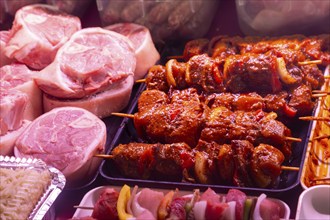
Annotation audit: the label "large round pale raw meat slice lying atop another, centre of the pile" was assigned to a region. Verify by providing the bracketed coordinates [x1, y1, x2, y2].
[35, 27, 136, 99]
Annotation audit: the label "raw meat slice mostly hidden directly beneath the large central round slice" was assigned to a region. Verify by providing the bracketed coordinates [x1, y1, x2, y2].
[43, 76, 134, 118]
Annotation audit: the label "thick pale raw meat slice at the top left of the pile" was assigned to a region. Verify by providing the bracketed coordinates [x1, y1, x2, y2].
[4, 4, 81, 70]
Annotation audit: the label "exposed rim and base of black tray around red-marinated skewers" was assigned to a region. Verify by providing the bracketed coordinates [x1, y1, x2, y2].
[99, 85, 314, 197]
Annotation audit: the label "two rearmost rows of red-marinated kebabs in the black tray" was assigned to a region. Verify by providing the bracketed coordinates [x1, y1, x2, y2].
[146, 35, 330, 94]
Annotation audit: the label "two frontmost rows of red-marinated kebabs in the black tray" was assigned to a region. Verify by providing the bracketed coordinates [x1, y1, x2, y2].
[111, 88, 291, 187]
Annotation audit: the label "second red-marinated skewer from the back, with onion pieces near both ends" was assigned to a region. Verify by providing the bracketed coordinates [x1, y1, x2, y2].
[145, 53, 324, 94]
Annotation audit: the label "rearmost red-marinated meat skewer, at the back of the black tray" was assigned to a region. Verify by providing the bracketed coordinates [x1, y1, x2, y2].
[182, 34, 330, 66]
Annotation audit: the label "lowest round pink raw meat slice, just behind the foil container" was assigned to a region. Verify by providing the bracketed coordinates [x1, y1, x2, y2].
[14, 107, 106, 185]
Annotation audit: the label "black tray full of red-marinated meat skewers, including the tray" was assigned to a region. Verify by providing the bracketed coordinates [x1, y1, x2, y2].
[100, 35, 330, 193]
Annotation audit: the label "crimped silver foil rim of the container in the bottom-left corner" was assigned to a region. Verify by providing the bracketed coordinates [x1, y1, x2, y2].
[0, 155, 66, 220]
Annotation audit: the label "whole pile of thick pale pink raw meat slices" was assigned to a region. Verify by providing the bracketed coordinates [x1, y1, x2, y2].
[0, 4, 160, 186]
